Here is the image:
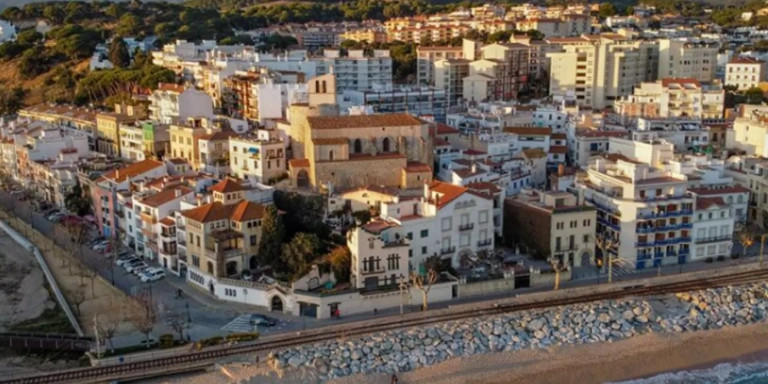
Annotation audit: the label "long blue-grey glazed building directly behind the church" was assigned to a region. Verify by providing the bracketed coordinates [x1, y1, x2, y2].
[338, 86, 447, 122]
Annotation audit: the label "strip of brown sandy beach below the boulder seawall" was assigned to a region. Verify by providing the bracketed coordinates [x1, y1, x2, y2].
[330, 323, 768, 384]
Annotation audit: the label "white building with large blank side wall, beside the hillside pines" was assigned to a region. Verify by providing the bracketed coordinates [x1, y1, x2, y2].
[149, 84, 214, 124]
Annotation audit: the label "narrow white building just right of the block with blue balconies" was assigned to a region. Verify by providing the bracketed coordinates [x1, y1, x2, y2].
[691, 196, 734, 261]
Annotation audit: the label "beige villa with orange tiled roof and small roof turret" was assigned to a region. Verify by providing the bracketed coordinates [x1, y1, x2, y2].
[181, 179, 266, 280]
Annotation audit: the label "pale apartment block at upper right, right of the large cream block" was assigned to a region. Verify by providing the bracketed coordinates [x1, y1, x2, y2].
[658, 39, 720, 82]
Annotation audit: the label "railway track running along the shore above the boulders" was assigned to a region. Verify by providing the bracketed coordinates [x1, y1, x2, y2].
[6, 270, 768, 384]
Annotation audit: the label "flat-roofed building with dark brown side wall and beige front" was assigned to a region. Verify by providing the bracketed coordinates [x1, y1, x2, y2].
[504, 191, 597, 268]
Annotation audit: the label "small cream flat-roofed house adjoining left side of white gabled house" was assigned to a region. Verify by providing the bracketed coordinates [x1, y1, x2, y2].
[347, 220, 410, 290]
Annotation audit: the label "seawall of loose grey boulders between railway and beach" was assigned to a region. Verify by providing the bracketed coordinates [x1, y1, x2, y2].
[272, 283, 768, 380]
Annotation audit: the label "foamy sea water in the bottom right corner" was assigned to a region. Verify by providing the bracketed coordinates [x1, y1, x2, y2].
[614, 361, 768, 384]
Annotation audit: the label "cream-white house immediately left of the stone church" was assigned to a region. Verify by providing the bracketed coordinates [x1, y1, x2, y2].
[229, 130, 287, 183]
